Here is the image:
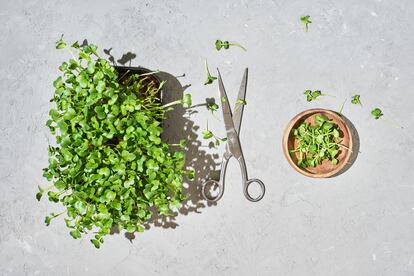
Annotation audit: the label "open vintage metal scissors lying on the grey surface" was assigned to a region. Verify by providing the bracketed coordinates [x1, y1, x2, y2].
[201, 68, 265, 202]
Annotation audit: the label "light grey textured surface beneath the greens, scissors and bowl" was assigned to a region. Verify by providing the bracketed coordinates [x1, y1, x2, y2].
[0, 0, 414, 275]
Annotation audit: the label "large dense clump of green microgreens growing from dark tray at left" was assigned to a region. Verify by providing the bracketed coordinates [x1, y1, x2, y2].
[36, 35, 190, 248]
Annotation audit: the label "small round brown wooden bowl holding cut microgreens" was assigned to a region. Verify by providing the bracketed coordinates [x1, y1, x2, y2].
[282, 108, 353, 178]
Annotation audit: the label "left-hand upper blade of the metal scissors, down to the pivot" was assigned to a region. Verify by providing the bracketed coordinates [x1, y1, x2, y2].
[217, 69, 243, 159]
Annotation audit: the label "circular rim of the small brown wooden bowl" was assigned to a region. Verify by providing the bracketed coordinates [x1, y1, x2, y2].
[282, 108, 353, 178]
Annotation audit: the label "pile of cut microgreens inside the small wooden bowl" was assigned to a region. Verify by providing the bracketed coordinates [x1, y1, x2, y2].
[289, 115, 341, 167]
